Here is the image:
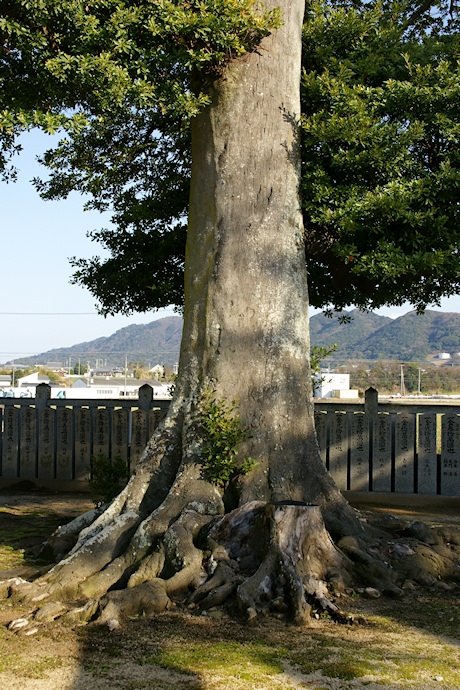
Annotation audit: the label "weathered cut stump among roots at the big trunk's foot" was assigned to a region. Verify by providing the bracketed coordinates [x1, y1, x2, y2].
[200, 502, 347, 623]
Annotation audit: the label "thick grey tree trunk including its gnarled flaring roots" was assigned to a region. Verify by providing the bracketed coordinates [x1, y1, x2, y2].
[2, 0, 416, 620]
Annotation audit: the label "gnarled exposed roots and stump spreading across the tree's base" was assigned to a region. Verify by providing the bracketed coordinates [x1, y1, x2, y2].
[0, 482, 460, 629]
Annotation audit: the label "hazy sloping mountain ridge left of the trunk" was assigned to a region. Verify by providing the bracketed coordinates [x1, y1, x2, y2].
[14, 316, 182, 366]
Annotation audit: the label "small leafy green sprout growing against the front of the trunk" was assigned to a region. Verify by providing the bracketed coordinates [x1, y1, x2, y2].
[200, 391, 257, 489]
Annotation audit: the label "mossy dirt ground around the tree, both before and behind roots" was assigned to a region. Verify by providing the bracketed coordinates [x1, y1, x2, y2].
[0, 490, 460, 690]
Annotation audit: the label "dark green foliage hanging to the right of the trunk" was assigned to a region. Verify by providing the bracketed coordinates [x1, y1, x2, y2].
[302, 3, 460, 310]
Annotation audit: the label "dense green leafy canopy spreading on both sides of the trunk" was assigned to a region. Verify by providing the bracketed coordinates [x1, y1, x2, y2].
[0, 0, 460, 313]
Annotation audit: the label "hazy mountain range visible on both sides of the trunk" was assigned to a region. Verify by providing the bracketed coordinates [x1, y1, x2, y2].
[9, 309, 460, 366]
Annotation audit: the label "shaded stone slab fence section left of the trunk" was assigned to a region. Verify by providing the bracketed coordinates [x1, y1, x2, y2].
[0, 384, 170, 490]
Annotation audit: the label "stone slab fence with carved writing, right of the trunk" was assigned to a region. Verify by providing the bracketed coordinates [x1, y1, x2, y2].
[315, 388, 460, 496]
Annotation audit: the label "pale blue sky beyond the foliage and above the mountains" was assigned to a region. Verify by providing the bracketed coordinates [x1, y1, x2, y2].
[0, 132, 460, 362]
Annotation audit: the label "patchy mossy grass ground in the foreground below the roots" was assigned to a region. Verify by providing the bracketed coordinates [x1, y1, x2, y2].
[0, 584, 460, 690]
